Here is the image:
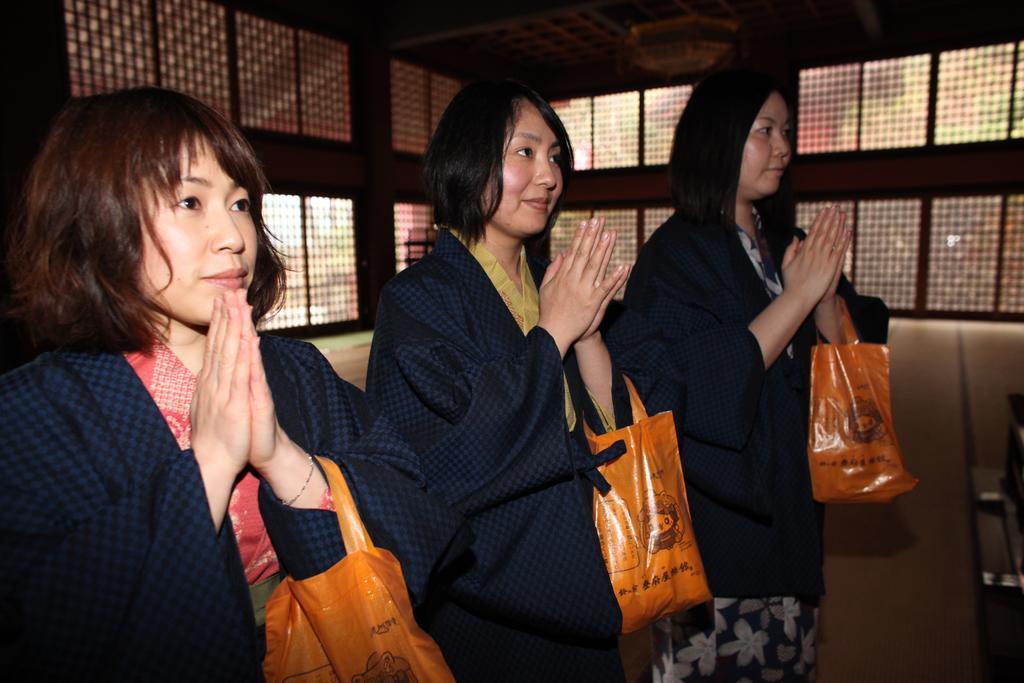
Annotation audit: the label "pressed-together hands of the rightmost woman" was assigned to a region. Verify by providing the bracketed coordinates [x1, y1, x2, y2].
[782, 206, 852, 312]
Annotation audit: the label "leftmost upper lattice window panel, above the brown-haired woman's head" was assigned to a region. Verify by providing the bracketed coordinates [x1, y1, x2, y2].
[64, 0, 157, 97]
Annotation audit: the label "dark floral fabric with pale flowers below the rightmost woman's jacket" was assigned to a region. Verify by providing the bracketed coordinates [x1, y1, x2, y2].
[651, 597, 818, 683]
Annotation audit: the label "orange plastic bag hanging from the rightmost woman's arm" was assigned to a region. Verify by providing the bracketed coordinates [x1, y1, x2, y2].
[807, 299, 918, 503]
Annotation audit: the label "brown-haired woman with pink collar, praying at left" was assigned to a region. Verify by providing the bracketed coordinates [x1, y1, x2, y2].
[0, 88, 461, 680]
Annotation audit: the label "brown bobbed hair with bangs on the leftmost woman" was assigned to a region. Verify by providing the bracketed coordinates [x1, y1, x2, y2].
[7, 88, 285, 352]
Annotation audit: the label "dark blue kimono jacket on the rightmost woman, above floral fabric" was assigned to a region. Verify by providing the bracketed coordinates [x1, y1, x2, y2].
[607, 214, 888, 597]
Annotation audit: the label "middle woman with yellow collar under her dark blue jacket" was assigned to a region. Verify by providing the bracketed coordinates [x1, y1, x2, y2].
[367, 81, 629, 681]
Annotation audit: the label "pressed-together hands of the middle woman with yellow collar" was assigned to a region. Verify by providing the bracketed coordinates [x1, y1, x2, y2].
[538, 217, 627, 357]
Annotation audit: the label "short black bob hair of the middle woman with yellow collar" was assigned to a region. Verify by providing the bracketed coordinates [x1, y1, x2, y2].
[423, 80, 572, 243]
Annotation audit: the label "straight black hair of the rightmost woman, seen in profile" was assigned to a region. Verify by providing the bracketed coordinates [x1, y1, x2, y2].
[669, 69, 795, 231]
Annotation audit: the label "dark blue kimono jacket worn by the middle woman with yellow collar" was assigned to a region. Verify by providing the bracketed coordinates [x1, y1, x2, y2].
[367, 230, 629, 683]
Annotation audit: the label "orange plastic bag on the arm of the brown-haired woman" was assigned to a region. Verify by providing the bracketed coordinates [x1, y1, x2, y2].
[263, 458, 455, 683]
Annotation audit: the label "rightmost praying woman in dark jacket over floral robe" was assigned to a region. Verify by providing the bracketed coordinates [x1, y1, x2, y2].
[608, 71, 884, 681]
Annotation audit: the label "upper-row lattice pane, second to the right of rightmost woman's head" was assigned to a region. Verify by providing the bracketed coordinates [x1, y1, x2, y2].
[860, 54, 932, 150]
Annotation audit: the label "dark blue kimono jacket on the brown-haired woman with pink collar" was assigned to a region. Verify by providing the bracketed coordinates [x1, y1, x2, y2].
[0, 337, 467, 681]
